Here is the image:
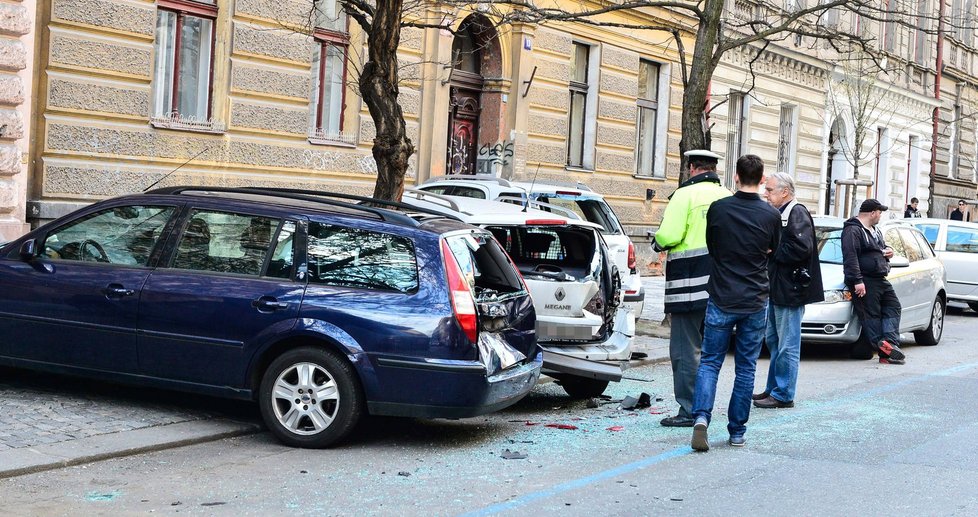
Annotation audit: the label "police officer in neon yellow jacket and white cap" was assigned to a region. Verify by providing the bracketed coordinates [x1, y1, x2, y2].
[653, 149, 730, 427]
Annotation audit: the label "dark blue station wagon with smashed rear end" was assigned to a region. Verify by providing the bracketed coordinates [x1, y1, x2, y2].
[0, 187, 542, 447]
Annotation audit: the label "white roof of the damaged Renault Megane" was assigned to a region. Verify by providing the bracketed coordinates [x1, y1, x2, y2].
[401, 189, 601, 231]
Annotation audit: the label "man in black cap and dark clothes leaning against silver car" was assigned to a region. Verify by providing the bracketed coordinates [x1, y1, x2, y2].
[842, 199, 906, 364]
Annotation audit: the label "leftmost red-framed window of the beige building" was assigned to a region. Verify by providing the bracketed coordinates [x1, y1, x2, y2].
[152, 0, 220, 130]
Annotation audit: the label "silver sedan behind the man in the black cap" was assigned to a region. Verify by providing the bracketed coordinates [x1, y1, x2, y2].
[801, 217, 947, 352]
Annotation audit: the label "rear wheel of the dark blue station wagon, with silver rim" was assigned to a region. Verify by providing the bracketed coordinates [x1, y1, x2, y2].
[258, 347, 364, 449]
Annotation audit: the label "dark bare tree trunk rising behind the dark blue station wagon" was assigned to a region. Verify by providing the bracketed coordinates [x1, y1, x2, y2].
[360, 0, 414, 201]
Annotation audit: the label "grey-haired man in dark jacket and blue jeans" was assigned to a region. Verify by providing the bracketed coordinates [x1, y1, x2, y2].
[753, 172, 825, 408]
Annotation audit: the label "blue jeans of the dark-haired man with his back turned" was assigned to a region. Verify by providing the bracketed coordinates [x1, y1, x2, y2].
[693, 300, 767, 436]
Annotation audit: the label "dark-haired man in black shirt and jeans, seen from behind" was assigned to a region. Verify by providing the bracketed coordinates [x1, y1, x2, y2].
[691, 154, 781, 451]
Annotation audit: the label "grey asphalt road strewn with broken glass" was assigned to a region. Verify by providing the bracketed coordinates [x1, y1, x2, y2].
[0, 311, 978, 516]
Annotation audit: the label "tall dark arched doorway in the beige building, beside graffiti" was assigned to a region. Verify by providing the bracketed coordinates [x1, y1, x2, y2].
[447, 15, 501, 174]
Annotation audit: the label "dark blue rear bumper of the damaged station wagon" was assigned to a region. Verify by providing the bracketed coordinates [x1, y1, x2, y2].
[367, 353, 543, 418]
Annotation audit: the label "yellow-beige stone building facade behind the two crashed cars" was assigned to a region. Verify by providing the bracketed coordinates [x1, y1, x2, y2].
[27, 0, 692, 256]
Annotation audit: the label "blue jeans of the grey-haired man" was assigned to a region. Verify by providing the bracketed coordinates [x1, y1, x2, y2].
[764, 303, 805, 402]
